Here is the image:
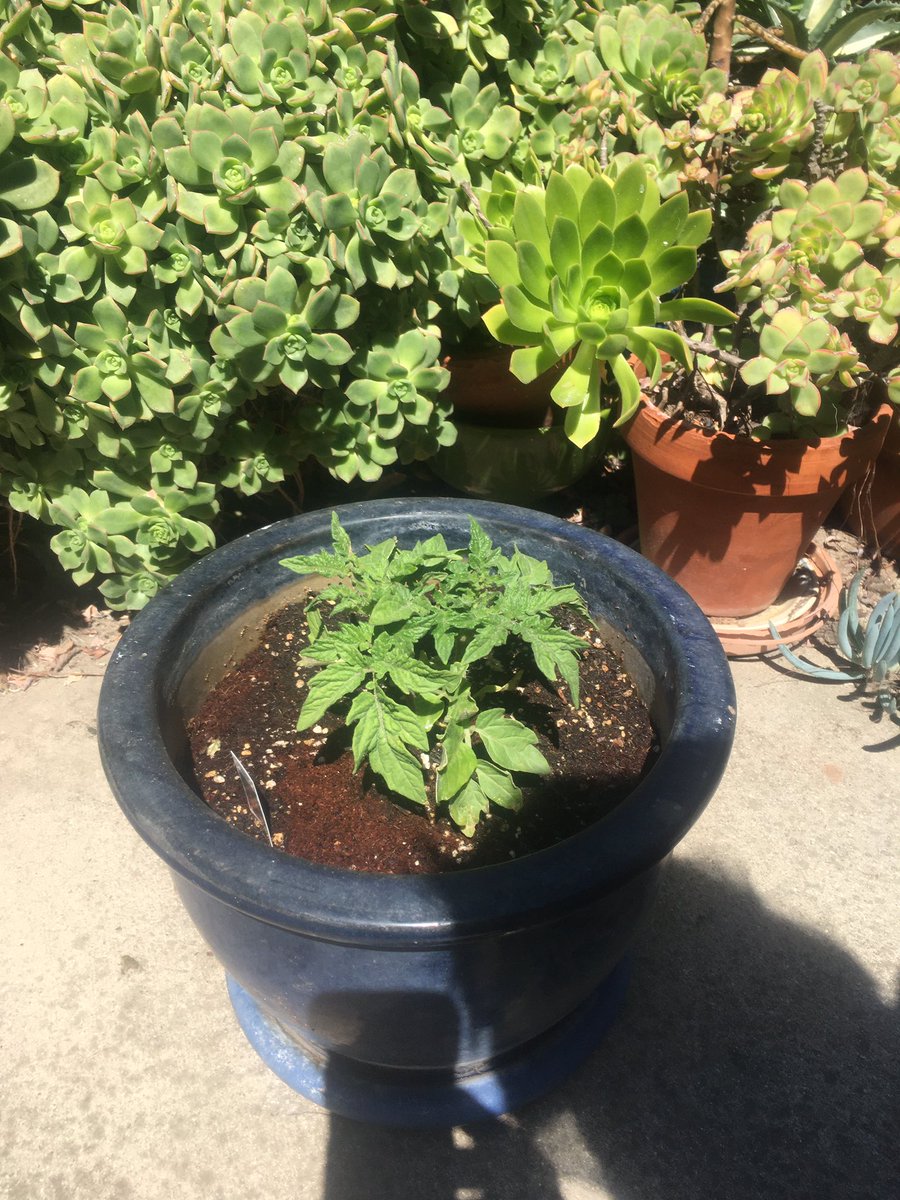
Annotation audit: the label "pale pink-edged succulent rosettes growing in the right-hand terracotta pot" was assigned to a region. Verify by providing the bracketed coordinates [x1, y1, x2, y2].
[720, 168, 900, 433]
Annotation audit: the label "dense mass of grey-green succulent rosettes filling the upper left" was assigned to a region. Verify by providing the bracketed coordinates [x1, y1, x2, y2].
[0, 0, 619, 606]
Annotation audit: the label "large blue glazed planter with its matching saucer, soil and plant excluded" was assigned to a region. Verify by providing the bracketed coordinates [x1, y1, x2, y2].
[98, 499, 734, 1126]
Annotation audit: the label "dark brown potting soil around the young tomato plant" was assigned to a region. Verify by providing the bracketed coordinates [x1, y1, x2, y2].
[188, 602, 658, 875]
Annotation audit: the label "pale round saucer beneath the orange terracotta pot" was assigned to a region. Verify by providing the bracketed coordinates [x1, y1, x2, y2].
[709, 545, 841, 659]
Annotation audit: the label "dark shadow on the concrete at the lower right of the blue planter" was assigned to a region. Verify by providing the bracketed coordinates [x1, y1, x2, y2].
[324, 860, 900, 1200]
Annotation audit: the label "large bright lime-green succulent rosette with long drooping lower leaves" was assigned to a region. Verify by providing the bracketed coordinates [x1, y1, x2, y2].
[485, 160, 733, 446]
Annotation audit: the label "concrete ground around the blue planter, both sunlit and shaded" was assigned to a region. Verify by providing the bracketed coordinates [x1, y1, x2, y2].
[0, 661, 900, 1200]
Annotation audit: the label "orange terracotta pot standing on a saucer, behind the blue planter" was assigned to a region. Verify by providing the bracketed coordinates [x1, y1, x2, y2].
[626, 401, 890, 617]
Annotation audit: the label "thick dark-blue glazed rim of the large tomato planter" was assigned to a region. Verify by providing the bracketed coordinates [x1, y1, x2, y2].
[98, 498, 736, 946]
